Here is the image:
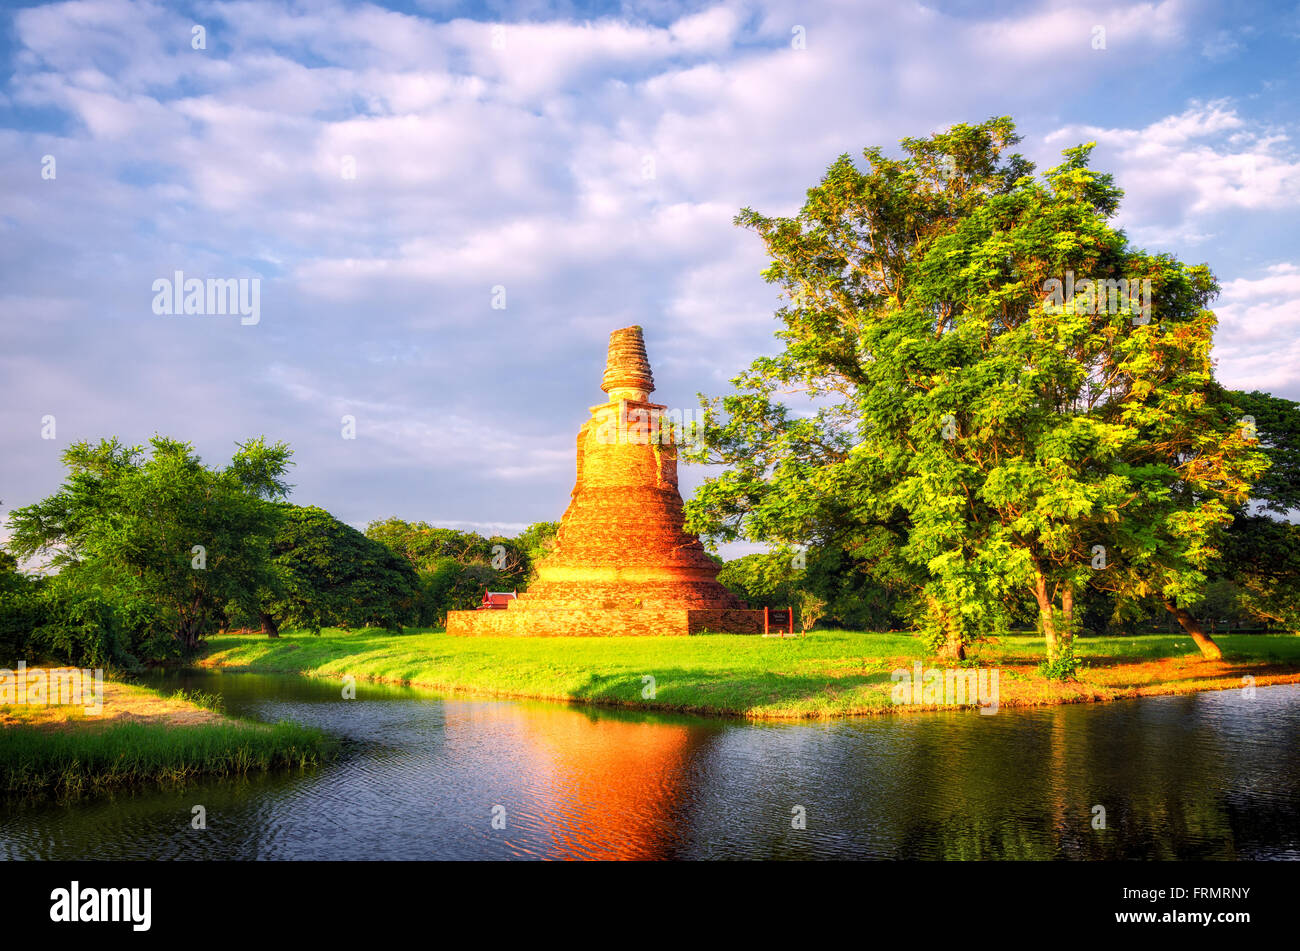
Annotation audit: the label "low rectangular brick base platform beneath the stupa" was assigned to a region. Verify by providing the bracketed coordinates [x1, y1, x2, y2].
[447, 605, 763, 638]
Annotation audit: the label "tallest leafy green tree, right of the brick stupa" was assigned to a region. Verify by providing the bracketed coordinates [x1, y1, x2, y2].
[688, 118, 1264, 659]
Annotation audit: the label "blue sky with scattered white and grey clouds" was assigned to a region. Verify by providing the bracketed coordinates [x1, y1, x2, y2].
[0, 0, 1300, 550]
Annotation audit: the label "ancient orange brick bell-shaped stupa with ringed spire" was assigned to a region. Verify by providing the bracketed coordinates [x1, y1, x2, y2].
[447, 327, 763, 637]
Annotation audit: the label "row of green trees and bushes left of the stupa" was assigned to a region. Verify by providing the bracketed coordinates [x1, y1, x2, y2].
[0, 437, 556, 668]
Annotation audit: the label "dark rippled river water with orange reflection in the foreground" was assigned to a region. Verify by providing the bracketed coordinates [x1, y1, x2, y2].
[0, 672, 1300, 859]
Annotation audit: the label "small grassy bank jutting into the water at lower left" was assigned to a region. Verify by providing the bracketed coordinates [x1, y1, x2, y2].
[0, 681, 333, 795]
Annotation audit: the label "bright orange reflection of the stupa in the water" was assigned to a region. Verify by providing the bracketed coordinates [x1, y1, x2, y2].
[446, 703, 701, 859]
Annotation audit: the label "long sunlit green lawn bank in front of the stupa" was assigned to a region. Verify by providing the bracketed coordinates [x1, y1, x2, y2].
[203, 629, 1300, 718]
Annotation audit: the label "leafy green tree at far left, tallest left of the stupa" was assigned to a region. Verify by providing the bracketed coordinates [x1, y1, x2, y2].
[9, 435, 293, 652]
